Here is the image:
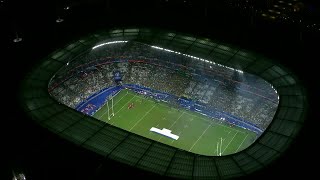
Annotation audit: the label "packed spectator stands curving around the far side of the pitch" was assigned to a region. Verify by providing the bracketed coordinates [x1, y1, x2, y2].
[48, 41, 279, 131]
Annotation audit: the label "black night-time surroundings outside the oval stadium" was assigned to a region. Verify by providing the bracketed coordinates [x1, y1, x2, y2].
[0, 0, 320, 180]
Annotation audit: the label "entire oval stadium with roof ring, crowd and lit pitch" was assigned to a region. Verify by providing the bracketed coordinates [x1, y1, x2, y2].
[21, 29, 306, 179]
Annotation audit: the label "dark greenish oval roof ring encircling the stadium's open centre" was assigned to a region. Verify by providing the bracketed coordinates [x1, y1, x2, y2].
[21, 29, 306, 179]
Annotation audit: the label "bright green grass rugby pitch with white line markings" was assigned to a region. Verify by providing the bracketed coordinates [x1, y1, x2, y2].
[93, 89, 256, 156]
